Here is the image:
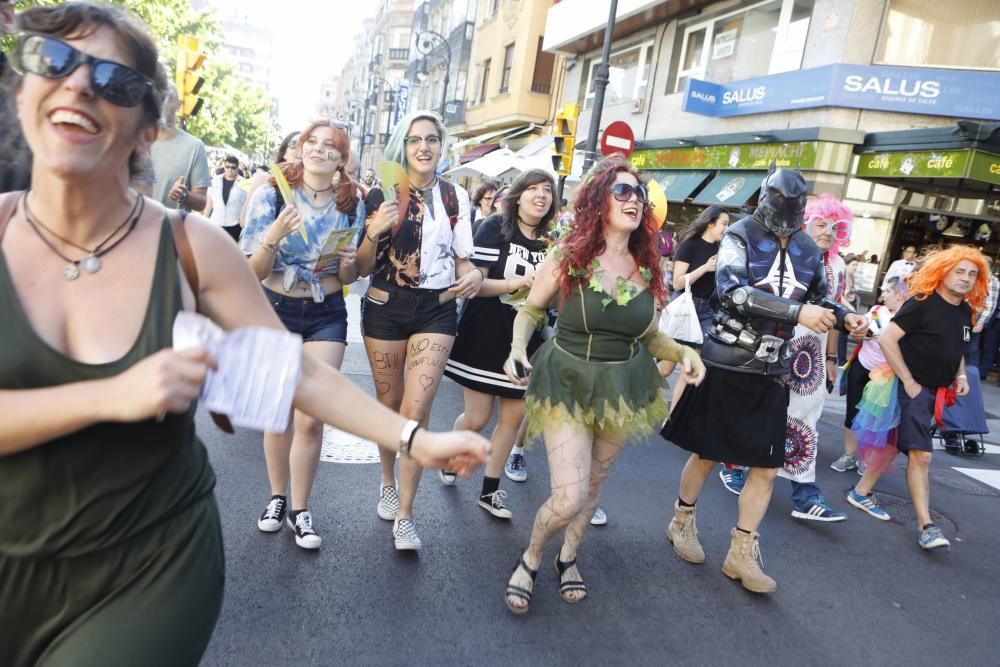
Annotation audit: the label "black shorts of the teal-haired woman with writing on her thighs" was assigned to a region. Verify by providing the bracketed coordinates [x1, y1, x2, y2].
[361, 284, 458, 340]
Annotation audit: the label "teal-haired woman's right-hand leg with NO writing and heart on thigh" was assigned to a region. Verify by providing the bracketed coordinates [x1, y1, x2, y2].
[397, 334, 455, 518]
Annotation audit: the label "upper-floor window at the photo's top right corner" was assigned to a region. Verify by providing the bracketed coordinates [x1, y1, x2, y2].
[875, 0, 1000, 69]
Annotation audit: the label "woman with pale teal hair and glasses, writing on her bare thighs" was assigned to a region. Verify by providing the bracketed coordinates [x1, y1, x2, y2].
[358, 111, 486, 550]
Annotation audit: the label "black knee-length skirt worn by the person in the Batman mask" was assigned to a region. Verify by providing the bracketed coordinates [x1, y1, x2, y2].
[660, 367, 788, 468]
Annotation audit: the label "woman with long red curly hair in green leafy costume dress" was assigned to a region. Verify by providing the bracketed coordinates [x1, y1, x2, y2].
[504, 157, 705, 614]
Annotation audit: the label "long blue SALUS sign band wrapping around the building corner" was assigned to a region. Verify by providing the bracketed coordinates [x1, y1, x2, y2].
[681, 64, 1000, 121]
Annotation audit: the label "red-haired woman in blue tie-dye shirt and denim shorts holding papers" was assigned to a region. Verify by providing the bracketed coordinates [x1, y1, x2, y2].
[240, 121, 365, 549]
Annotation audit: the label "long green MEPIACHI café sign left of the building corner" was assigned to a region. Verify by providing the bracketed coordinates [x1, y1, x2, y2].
[630, 141, 820, 169]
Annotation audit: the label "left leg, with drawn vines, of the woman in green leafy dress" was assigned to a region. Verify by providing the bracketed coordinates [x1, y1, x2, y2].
[507, 424, 593, 607]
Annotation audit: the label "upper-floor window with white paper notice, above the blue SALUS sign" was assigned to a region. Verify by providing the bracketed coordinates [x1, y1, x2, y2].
[667, 0, 815, 93]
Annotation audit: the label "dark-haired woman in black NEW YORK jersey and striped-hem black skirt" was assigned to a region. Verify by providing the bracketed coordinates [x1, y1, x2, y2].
[444, 169, 556, 519]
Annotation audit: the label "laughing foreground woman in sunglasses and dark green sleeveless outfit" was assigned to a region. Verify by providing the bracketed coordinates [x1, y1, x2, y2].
[0, 2, 488, 665]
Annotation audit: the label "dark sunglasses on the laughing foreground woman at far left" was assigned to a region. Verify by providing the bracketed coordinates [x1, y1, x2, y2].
[11, 32, 153, 107]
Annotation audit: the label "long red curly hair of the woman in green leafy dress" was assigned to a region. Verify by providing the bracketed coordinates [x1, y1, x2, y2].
[559, 155, 667, 308]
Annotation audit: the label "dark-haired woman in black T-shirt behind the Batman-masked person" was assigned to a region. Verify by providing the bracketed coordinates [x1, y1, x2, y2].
[660, 206, 729, 405]
